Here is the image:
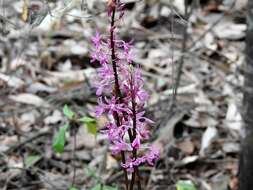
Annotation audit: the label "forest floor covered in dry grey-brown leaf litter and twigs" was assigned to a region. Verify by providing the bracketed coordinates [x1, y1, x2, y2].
[0, 0, 246, 190]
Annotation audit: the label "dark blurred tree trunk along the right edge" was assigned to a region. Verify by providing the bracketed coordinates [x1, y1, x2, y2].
[239, 0, 253, 190]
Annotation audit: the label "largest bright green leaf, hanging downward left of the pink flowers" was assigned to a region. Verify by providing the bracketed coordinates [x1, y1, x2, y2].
[53, 124, 69, 153]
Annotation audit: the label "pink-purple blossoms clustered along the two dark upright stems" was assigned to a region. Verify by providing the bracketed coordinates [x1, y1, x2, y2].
[91, 0, 159, 172]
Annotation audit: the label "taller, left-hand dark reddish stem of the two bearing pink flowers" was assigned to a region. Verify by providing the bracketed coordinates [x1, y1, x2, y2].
[110, 0, 128, 190]
